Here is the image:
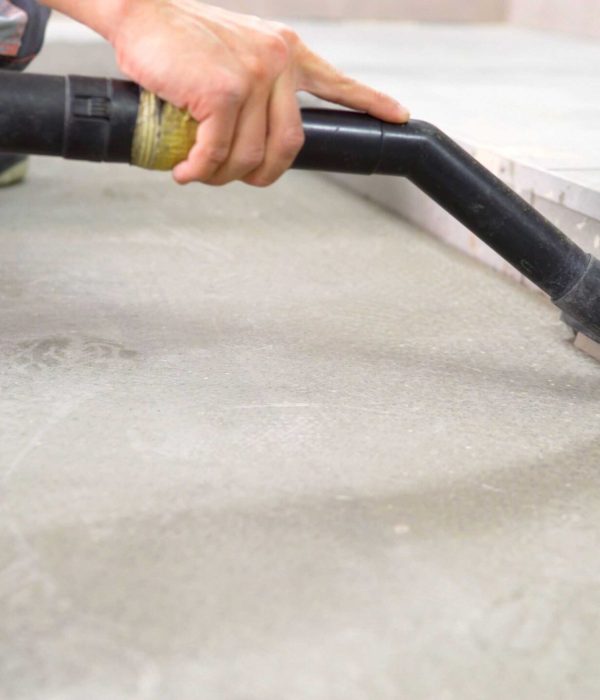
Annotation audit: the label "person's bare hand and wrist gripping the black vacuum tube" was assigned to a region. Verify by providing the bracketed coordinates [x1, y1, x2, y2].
[43, 0, 408, 186]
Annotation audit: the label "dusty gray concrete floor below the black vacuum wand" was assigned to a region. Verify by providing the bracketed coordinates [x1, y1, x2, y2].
[0, 160, 600, 700]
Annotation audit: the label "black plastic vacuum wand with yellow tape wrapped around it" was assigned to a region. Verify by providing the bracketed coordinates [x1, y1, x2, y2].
[0, 71, 600, 356]
